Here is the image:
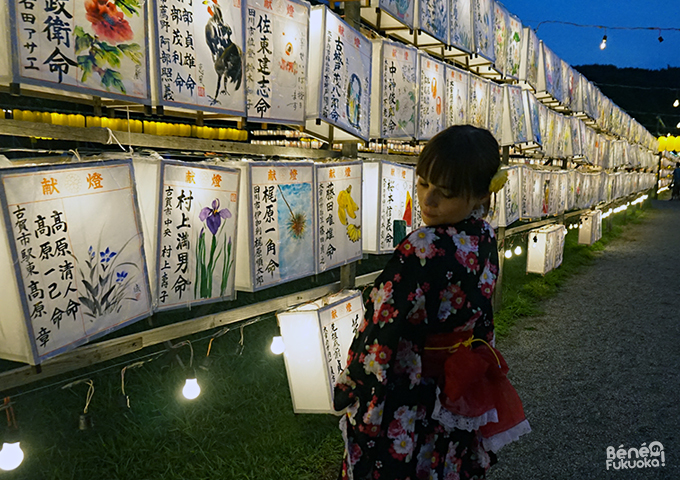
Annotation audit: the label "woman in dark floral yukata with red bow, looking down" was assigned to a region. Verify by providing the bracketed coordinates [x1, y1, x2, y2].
[334, 126, 528, 480]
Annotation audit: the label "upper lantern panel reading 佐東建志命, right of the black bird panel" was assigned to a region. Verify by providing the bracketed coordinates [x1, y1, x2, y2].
[246, 0, 310, 125]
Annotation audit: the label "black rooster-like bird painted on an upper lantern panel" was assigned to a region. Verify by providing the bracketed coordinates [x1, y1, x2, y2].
[203, 0, 243, 105]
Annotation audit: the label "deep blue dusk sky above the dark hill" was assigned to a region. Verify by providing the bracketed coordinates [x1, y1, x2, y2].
[502, 0, 680, 70]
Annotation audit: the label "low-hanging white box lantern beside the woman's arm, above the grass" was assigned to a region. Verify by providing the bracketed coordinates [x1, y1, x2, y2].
[276, 291, 364, 413]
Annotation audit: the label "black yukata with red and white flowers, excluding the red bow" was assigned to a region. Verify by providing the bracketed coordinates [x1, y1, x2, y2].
[334, 217, 498, 480]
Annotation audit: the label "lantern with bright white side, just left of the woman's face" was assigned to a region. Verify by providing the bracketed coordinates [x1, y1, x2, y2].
[362, 161, 415, 254]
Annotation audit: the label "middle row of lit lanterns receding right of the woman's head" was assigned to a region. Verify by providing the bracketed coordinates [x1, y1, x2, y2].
[489, 166, 656, 227]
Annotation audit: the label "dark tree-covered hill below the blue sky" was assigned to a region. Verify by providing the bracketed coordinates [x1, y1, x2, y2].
[574, 65, 680, 135]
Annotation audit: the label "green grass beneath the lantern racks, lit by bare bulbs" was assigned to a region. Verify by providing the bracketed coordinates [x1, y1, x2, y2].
[0, 200, 645, 480]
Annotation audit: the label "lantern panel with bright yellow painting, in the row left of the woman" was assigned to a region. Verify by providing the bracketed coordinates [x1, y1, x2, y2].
[316, 161, 363, 272]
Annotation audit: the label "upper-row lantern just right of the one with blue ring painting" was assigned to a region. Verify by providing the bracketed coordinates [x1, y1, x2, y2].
[371, 39, 418, 139]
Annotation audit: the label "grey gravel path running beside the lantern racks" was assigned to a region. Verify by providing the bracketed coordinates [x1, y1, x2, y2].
[488, 201, 680, 480]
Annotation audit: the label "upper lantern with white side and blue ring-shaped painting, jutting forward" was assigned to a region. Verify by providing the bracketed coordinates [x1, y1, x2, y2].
[306, 5, 373, 141]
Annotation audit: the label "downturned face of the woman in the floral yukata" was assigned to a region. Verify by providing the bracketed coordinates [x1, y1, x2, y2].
[417, 176, 487, 226]
